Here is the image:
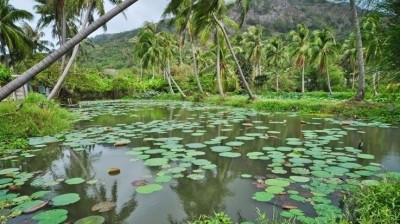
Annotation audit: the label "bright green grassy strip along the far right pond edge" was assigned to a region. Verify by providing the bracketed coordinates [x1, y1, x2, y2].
[152, 94, 400, 124]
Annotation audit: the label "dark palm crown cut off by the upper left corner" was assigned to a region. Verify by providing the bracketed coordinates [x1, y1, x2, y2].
[0, 0, 33, 66]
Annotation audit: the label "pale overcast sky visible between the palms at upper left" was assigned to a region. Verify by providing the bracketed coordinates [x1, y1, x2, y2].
[10, 0, 168, 43]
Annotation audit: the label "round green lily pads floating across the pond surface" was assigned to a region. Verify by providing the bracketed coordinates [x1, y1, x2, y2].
[0, 101, 390, 223]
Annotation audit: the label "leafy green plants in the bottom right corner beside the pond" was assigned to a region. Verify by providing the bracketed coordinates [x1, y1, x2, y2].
[347, 178, 400, 223]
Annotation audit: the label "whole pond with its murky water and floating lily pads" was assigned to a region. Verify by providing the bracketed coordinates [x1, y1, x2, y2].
[0, 101, 400, 224]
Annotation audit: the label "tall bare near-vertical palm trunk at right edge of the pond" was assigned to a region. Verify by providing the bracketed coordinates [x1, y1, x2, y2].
[350, 0, 365, 100]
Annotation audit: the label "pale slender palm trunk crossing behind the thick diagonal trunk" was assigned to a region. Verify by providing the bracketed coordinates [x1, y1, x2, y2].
[47, 1, 93, 100]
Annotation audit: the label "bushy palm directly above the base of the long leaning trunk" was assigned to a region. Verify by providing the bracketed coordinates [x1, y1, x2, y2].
[241, 26, 265, 79]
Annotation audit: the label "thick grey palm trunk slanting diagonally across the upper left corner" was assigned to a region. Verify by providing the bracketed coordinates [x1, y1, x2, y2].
[0, 0, 138, 101]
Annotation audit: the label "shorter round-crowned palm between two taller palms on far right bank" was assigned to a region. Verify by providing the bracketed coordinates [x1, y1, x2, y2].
[266, 37, 288, 92]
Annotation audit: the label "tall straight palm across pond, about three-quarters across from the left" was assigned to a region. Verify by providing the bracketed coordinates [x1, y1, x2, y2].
[289, 24, 311, 93]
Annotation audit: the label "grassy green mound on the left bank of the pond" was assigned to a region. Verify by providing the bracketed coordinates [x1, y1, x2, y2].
[0, 93, 73, 151]
